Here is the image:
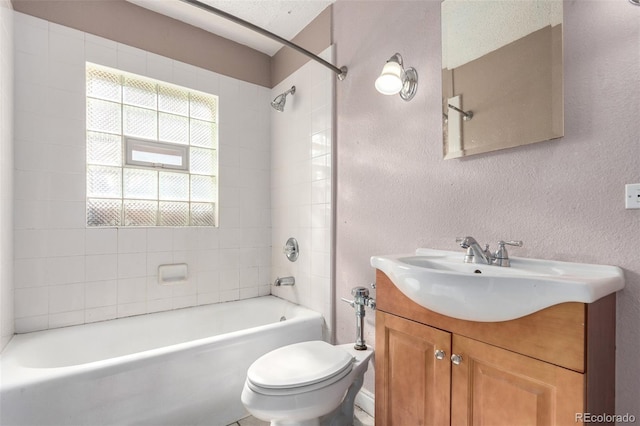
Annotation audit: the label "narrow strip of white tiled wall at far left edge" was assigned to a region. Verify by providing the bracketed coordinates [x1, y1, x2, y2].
[0, 0, 14, 351]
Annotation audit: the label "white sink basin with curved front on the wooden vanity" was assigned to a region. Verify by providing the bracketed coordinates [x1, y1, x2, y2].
[371, 248, 624, 322]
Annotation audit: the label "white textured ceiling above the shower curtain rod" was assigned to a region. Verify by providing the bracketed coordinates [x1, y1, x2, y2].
[127, 0, 335, 56]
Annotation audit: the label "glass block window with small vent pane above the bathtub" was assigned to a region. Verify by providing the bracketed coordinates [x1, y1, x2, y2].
[86, 63, 218, 227]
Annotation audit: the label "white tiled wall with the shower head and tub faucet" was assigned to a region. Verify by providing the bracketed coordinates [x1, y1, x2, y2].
[271, 47, 335, 335]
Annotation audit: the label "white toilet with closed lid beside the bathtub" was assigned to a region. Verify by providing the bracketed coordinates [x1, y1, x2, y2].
[242, 340, 373, 426]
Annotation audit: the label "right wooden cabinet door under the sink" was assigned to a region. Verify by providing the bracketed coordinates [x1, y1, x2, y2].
[451, 335, 585, 426]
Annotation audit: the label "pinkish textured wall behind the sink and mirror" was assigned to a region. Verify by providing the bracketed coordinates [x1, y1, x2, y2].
[334, 0, 640, 417]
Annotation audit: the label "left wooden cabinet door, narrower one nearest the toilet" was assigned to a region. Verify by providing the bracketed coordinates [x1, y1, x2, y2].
[375, 311, 451, 426]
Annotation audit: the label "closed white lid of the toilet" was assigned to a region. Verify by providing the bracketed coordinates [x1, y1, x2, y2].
[247, 340, 354, 389]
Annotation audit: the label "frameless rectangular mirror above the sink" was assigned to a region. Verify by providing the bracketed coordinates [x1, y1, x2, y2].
[441, 0, 564, 159]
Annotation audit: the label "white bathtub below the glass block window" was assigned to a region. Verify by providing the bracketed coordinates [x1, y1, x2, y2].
[0, 296, 324, 426]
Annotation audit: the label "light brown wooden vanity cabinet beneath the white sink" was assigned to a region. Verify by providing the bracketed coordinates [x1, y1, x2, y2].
[375, 270, 615, 426]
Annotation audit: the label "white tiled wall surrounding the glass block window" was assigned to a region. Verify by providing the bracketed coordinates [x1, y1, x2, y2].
[11, 9, 272, 332]
